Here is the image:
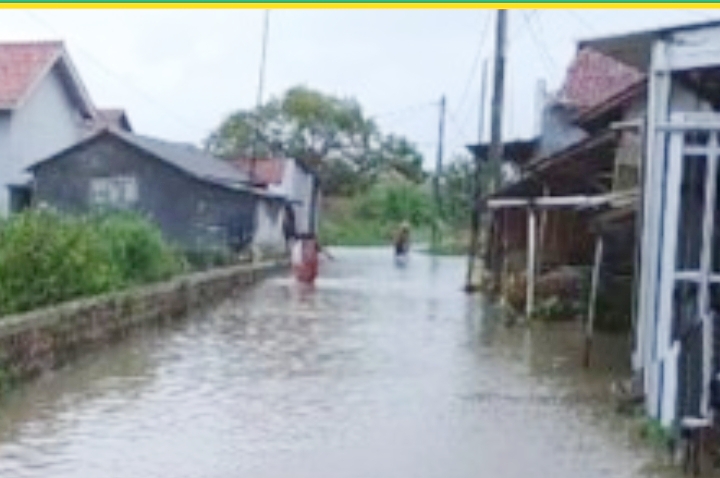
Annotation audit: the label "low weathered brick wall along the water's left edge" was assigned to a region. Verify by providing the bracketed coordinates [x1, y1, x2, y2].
[0, 263, 285, 380]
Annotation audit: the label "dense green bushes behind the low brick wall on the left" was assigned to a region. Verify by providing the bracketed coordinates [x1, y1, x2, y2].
[0, 211, 185, 315]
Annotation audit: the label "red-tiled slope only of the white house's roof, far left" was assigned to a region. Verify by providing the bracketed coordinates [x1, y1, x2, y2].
[0, 42, 63, 108]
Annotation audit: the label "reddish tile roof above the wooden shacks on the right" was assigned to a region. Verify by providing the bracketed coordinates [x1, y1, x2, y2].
[560, 48, 644, 110]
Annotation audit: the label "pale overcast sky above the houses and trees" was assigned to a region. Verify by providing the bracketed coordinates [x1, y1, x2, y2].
[0, 9, 720, 169]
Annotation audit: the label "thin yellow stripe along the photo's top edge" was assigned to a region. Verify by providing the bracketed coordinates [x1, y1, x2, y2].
[0, 0, 720, 10]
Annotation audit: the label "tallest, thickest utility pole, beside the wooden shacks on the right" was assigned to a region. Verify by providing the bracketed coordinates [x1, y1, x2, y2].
[485, 10, 507, 287]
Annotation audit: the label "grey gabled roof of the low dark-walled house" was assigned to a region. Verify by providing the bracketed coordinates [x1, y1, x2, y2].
[27, 128, 284, 200]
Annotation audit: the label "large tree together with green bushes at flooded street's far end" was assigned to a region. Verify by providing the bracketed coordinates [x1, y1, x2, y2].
[205, 86, 487, 254]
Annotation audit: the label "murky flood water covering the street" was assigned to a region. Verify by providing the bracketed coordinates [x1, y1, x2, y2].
[0, 249, 676, 478]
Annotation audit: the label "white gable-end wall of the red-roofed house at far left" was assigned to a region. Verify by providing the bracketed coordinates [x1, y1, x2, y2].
[0, 64, 85, 215]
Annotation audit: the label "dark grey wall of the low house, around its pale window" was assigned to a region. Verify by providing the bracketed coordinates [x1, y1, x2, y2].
[34, 134, 257, 251]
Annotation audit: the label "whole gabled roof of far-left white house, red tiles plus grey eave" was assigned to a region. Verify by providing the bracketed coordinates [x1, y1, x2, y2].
[0, 41, 96, 118]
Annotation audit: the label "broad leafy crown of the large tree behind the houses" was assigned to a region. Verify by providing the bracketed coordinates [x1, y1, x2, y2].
[206, 86, 425, 195]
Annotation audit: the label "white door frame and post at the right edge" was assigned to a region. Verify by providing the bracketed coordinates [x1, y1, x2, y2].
[646, 113, 720, 424]
